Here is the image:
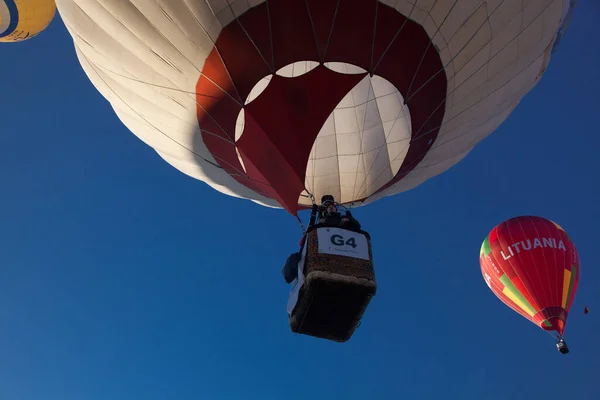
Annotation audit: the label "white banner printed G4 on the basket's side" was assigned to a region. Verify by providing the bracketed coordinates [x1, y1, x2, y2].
[317, 228, 370, 260]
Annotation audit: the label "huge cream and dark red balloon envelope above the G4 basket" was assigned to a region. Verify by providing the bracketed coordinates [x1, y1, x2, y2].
[57, 0, 573, 214]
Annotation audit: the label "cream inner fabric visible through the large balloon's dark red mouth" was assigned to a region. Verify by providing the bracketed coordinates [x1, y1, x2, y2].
[235, 61, 412, 207]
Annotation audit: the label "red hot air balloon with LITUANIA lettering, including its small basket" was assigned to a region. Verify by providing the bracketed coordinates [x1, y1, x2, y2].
[479, 216, 579, 353]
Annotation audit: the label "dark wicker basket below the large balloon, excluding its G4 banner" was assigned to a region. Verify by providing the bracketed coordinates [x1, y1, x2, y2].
[290, 230, 377, 342]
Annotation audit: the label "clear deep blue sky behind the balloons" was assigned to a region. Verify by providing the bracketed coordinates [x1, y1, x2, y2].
[0, 1, 600, 400]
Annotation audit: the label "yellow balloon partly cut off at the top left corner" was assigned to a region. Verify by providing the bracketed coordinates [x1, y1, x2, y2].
[0, 0, 56, 42]
